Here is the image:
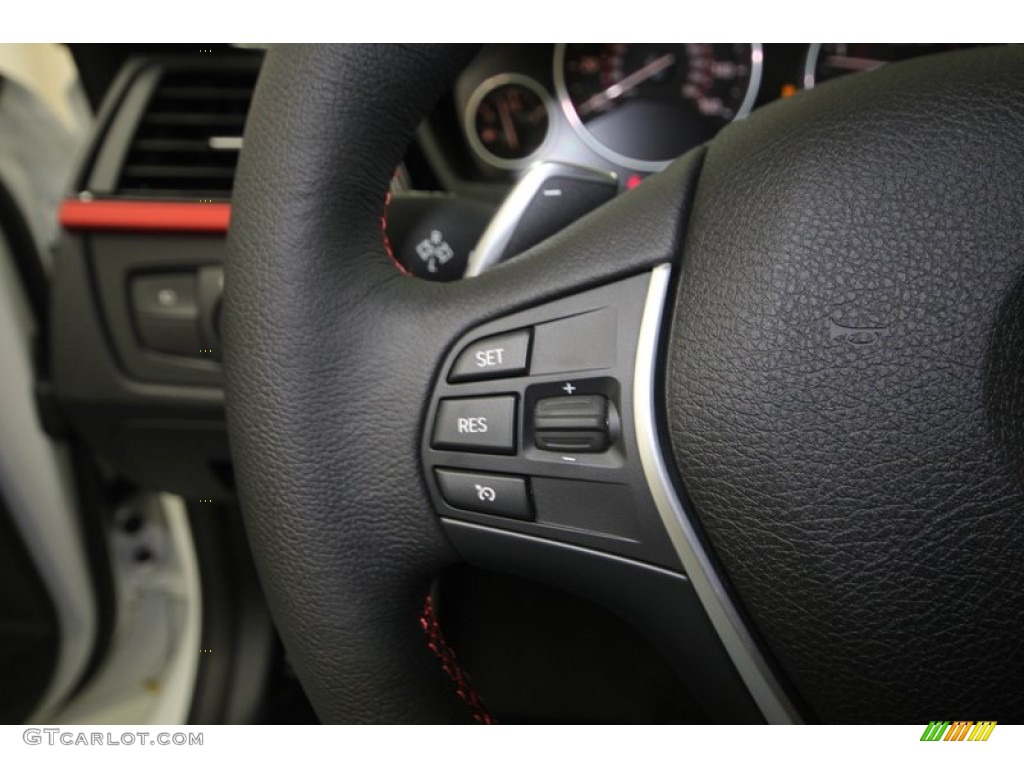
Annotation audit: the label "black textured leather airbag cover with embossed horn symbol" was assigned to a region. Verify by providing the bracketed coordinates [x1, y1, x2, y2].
[667, 48, 1024, 723]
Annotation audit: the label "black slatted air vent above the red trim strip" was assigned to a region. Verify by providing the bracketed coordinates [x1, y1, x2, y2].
[117, 67, 258, 200]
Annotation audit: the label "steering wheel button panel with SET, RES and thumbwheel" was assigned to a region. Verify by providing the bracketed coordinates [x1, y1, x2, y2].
[423, 274, 678, 567]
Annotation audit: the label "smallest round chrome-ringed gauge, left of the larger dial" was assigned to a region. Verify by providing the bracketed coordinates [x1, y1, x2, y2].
[466, 75, 550, 168]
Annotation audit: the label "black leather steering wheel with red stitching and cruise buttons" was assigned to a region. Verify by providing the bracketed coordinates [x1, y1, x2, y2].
[224, 45, 1024, 722]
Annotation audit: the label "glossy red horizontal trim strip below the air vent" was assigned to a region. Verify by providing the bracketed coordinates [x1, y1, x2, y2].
[60, 200, 231, 233]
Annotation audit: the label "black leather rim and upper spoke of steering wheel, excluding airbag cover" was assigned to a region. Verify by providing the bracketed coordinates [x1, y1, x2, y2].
[224, 46, 700, 722]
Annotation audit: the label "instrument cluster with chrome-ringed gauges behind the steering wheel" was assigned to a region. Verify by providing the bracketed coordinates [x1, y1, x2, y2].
[421, 43, 983, 187]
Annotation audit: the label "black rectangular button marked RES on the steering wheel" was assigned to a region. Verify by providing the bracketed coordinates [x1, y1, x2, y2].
[432, 395, 515, 454]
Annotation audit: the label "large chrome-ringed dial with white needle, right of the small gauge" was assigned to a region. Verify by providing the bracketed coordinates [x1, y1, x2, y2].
[555, 43, 762, 171]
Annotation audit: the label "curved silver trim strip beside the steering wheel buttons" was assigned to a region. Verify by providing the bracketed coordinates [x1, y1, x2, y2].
[633, 264, 803, 724]
